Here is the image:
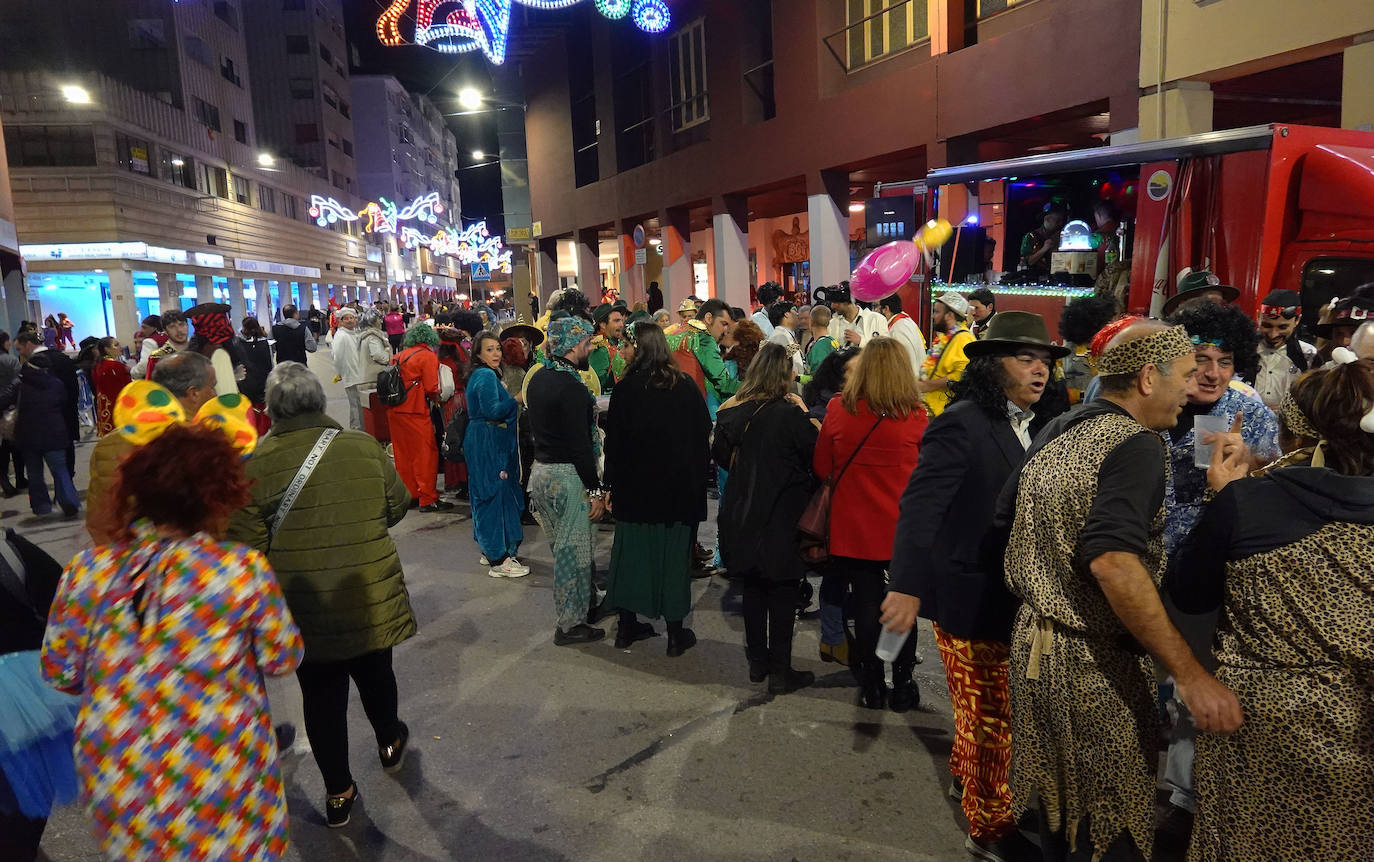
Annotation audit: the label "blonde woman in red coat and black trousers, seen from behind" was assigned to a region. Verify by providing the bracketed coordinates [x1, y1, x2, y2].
[813, 338, 929, 712]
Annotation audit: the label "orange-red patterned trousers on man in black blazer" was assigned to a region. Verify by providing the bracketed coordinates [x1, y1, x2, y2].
[933, 626, 1017, 840]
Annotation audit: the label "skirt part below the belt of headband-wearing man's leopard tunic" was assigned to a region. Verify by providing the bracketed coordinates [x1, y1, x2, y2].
[1011, 605, 1160, 859]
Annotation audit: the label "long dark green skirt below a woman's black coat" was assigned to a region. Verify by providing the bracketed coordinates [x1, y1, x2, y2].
[606, 521, 691, 623]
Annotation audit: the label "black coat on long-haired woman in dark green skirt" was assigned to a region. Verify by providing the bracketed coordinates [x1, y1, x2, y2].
[602, 371, 710, 524]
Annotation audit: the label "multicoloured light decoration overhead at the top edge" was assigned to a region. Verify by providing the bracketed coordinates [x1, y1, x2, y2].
[376, 0, 672, 66]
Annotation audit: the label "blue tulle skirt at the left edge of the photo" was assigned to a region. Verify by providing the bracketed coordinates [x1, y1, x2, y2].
[0, 650, 81, 819]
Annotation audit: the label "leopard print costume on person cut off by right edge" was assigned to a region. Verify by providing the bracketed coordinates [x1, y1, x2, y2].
[1189, 522, 1374, 862]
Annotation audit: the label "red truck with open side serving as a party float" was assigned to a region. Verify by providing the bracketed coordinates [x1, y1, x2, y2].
[926, 124, 1374, 331]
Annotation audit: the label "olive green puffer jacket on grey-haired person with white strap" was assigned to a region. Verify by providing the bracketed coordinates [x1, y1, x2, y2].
[228, 414, 415, 663]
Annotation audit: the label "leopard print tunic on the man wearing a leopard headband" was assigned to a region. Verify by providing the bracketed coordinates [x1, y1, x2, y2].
[1006, 414, 1168, 858]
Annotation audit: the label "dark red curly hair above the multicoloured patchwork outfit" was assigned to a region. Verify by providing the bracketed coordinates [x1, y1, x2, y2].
[98, 423, 251, 539]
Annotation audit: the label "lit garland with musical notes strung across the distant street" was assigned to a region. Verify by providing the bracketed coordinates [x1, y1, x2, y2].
[309, 191, 513, 274]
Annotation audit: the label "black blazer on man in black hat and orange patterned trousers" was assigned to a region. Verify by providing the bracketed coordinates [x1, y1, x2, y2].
[889, 401, 1025, 643]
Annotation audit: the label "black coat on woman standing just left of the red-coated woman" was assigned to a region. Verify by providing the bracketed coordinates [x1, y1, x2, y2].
[712, 401, 819, 580]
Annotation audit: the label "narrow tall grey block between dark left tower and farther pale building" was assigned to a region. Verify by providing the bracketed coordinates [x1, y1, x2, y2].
[245, 0, 359, 195]
